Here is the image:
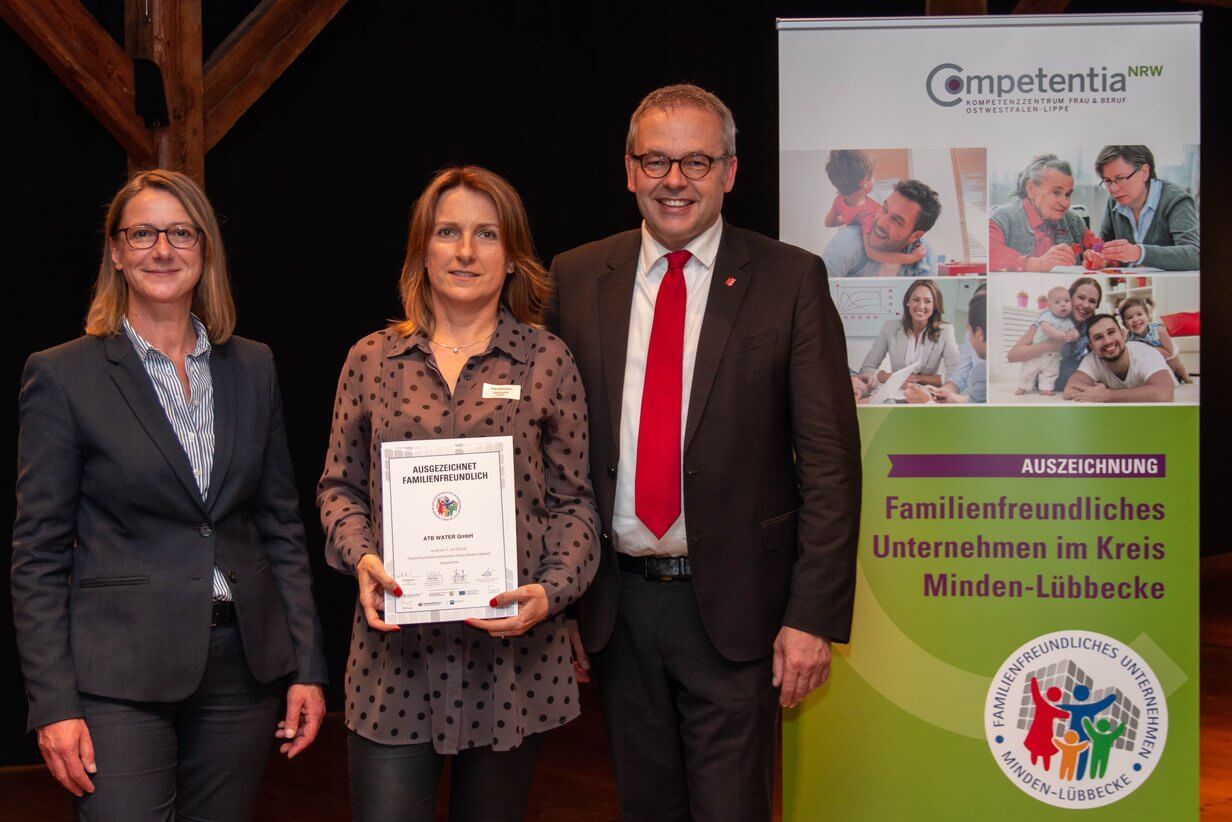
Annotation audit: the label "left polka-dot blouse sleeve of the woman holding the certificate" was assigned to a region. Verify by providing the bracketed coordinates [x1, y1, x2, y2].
[317, 348, 381, 574]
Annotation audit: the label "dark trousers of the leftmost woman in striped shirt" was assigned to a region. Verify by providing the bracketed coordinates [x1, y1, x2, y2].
[76, 625, 282, 822]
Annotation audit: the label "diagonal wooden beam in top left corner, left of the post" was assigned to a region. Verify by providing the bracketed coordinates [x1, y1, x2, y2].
[0, 0, 154, 160]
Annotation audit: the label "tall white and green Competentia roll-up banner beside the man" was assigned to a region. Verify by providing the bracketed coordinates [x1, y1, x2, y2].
[779, 14, 1201, 821]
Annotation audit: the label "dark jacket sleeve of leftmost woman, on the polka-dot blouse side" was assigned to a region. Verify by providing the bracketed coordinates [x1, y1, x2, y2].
[253, 346, 329, 684]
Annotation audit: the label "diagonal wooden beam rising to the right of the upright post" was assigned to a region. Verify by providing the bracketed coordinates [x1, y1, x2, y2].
[205, 0, 346, 150]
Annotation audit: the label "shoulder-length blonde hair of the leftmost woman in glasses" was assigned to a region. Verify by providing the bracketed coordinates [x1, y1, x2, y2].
[85, 169, 235, 343]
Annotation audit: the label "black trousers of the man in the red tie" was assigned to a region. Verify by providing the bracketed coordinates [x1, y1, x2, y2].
[591, 573, 779, 822]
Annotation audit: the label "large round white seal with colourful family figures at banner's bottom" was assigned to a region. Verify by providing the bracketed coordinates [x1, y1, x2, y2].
[984, 631, 1168, 808]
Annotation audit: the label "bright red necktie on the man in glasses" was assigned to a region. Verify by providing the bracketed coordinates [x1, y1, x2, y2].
[633, 251, 692, 537]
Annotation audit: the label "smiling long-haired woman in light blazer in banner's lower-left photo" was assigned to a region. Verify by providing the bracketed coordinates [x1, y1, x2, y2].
[860, 280, 958, 386]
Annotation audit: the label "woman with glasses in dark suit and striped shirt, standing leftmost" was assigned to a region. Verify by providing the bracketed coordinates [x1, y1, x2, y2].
[12, 170, 325, 820]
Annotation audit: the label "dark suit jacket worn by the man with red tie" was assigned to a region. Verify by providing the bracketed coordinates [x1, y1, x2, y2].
[549, 224, 860, 661]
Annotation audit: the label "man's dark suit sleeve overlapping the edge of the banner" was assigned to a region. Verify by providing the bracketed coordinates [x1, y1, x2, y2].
[784, 256, 861, 642]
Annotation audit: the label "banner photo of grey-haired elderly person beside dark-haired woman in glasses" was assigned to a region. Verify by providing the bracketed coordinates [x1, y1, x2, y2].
[988, 145, 1199, 276]
